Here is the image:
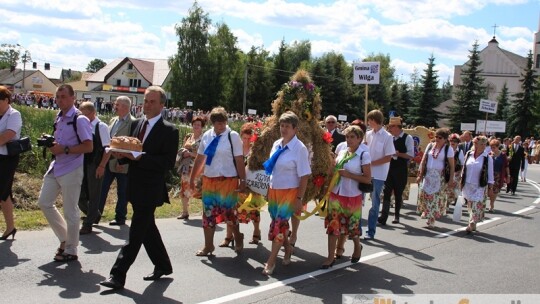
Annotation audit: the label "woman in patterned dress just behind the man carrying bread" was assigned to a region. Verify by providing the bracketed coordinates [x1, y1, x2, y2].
[176, 116, 205, 220]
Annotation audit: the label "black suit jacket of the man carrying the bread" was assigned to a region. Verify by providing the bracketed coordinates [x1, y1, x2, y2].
[128, 118, 179, 206]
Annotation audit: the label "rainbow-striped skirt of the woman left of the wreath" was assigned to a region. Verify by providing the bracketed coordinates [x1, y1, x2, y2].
[202, 176, 238, 228]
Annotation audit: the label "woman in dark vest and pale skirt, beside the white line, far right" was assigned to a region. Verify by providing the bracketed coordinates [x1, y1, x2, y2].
[461, 136, 495, 233]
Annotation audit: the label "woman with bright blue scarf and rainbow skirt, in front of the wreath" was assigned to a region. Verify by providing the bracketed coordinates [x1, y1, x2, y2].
[260, 111, 311, 275]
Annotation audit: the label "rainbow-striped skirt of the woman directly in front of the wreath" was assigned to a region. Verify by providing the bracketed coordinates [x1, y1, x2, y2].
[268, 188, 298, 242]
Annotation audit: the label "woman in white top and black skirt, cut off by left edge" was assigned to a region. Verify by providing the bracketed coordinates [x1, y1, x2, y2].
[0, 86, 22, 240]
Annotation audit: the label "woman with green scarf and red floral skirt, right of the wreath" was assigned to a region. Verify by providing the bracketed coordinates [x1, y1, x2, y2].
[321, 126, 371, 269]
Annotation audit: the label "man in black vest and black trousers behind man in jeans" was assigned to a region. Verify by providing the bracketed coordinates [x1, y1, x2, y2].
[378, 117, 414, 226]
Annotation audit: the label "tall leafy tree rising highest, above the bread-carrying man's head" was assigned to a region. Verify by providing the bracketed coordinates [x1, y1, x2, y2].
[169, 1, 211, 110]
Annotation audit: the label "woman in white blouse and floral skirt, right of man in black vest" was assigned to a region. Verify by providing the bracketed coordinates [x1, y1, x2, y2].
[416, 128, 454, 229]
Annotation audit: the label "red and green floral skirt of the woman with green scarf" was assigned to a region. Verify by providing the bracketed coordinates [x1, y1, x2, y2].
[324, 193, 362, 237]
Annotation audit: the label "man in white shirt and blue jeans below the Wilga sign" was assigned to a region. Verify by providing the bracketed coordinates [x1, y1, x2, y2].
[364, 110, 396, 240]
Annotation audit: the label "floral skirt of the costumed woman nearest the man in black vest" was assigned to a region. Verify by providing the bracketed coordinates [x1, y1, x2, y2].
[417, 169, 447, 224]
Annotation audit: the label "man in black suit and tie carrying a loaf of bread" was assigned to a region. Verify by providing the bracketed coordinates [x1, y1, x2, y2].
[100, 86, 179, 289]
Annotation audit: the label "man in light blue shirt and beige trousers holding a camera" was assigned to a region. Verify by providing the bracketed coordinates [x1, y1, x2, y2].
[38, 84, 93, 262]
